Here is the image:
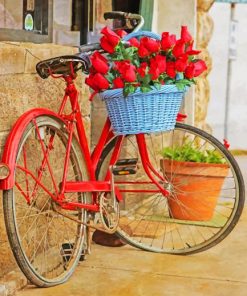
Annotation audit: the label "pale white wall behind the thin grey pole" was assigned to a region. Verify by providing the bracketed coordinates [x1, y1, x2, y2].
[207, 3, 247, 150]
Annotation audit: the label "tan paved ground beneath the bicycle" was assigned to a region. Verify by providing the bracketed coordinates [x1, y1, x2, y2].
[18, 157, 247, 296]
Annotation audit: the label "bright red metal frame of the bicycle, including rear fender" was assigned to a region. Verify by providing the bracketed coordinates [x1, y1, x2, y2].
[0, 72, 172, 211]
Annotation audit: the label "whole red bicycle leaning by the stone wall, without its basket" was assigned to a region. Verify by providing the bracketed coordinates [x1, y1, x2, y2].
[0, 13, 244, 287]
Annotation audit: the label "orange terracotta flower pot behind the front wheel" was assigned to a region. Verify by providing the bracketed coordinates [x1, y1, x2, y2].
[161, 159, 229, 221]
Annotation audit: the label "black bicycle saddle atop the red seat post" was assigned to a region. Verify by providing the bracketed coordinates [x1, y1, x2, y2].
[36, 53, 90, 79]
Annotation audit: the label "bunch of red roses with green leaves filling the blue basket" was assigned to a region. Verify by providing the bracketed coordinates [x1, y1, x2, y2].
[85, 26, 207, 96]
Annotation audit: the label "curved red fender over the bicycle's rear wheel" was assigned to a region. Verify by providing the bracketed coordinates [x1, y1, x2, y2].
[0, 108, 64, 190]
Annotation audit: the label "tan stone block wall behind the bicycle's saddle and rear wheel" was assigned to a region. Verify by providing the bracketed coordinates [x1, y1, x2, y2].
[0, 42, 90, 277]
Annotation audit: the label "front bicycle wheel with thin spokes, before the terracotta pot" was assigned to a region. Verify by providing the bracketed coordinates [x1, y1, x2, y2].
[98, 123, 244, 254]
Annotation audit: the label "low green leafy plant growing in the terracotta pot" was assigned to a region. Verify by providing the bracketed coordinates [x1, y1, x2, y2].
[161, 142, 225, 163]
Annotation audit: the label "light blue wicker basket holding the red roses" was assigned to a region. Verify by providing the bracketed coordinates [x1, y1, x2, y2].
[100, 85, 184, 135]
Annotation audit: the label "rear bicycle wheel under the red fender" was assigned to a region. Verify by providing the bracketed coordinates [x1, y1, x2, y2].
[3, 116, 87, 287]
